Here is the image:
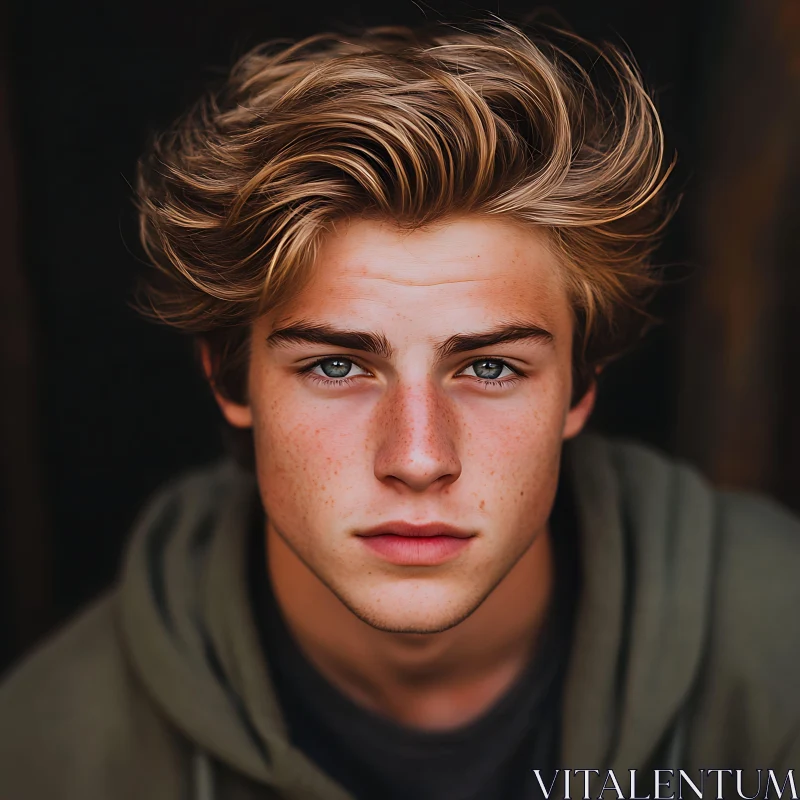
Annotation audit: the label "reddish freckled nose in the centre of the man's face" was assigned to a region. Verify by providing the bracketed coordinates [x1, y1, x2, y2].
[375, 381, 461, 492]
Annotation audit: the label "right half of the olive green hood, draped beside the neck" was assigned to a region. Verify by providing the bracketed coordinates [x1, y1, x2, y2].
[562, 435, 716, 776]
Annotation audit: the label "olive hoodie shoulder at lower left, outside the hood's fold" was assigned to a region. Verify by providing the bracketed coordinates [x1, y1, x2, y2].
[0, 594, 186, 800]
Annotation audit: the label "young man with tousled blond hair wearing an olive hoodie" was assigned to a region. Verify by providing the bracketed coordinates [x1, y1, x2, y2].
[0, 18, 800, 800]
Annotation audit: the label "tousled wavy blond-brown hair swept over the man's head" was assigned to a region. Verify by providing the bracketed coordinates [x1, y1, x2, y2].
[137, 21, 671, 401]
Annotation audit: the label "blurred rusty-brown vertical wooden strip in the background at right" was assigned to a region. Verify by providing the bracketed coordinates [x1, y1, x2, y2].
[675, 0, 800, 496]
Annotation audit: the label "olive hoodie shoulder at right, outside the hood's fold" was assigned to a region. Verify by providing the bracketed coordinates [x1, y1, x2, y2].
[692, 492, 800, 768]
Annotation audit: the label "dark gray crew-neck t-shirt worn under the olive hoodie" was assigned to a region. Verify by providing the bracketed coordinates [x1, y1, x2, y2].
[251, 466, 578, 800]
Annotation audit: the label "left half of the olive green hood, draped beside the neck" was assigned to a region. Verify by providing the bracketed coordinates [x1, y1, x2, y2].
[121, 460, 349, 800]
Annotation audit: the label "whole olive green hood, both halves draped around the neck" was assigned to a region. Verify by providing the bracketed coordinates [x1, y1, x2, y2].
[115, 435, 713, 800]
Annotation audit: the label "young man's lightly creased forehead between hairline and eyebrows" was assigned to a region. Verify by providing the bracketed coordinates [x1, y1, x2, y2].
[282, 216, 568, 324]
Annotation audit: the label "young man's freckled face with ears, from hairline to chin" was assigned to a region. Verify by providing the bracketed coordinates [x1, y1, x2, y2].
[212, 217, 593, 633]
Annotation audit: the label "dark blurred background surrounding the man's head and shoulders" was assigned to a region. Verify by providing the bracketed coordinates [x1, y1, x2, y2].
[0, 0, 800, 667]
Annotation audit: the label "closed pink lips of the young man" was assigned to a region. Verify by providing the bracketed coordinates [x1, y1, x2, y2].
[358, 522, 475, 567]
